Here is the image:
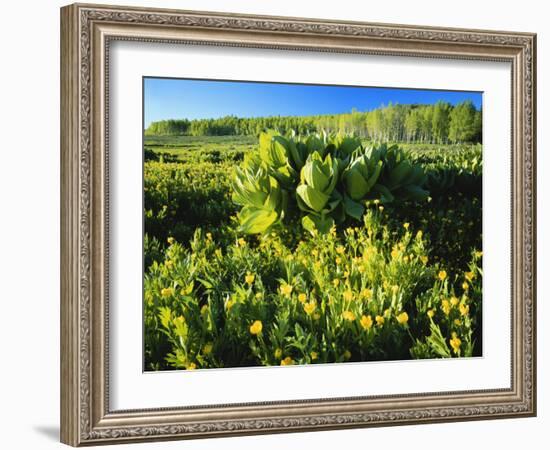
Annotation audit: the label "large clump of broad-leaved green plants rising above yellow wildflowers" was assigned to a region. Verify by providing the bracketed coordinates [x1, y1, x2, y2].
[233, 131, 428, 234]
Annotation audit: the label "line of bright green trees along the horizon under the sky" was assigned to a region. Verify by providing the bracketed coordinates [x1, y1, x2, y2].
[145, 100, 482, 144]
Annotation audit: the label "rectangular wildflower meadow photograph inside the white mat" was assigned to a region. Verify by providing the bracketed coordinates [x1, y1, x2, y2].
[142, 76, 483, 372]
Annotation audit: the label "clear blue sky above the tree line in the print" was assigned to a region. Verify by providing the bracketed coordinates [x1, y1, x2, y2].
[144, 78, 482, 127]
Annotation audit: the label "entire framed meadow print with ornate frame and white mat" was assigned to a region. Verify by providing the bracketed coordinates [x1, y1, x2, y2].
[61, 4, 536, 446]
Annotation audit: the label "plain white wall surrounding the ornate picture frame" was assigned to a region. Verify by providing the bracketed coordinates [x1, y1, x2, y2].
[0, 0, 550, 450]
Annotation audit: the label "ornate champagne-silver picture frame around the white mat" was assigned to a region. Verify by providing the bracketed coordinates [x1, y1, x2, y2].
[61, 4, 536, 446]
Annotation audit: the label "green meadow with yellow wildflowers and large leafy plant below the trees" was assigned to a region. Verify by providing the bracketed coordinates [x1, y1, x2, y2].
[143, 132, 483, 370]
